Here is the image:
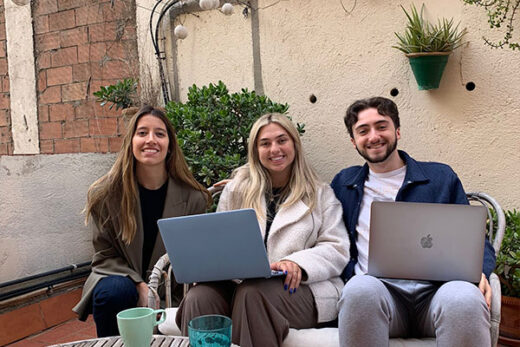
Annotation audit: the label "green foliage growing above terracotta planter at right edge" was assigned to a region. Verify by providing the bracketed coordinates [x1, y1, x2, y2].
[495, 210, 520, 298]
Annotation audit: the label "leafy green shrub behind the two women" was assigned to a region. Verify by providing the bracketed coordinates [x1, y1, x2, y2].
[166, 81, 305, 190]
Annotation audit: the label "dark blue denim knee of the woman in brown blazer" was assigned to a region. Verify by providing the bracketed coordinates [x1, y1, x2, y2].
[92, 276, 138, 308]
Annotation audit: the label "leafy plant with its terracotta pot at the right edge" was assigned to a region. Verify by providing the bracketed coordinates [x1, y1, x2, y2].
[495, 210, 520, 346]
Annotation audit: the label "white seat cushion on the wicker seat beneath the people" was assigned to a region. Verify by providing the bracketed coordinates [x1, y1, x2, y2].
[159, 307, 436, 347]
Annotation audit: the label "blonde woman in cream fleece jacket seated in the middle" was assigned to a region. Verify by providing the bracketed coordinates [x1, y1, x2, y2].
[176, 114, 349, 347]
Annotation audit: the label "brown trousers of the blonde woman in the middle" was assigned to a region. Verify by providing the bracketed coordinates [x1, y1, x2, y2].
[176, 277, 317, 347]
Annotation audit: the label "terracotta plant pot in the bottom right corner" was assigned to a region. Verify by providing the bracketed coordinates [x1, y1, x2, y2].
[499, 296, 520, 346]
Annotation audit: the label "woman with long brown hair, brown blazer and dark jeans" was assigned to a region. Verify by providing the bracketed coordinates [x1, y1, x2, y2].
[74, 106, 211, 337]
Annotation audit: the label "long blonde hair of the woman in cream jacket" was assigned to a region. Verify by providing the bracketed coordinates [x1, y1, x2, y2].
[233, 113, 319, 219]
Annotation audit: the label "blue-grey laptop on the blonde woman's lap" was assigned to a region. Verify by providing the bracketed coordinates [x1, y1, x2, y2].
[157, 209, 281, 283]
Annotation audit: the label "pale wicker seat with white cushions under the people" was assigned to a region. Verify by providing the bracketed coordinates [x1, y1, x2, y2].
[148, 190, 505, 347]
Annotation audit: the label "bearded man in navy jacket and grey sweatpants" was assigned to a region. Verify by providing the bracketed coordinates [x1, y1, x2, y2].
[331, 97, 495, 347]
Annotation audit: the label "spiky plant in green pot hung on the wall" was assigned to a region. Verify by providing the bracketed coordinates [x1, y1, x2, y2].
[393, 4, 466, 90]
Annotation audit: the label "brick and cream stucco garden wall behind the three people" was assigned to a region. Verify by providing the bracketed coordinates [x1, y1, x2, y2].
[0, 0, 520, 282]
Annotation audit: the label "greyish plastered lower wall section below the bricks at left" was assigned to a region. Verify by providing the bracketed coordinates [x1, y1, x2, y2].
[0, 153, 114, 282]
